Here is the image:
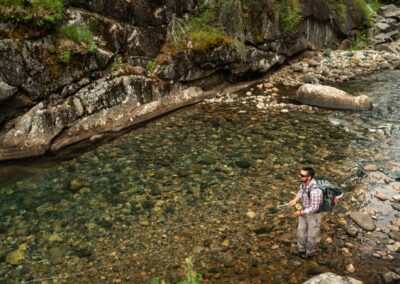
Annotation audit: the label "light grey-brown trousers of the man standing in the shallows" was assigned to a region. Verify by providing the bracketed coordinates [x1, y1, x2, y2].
[297, 212, 324, 254]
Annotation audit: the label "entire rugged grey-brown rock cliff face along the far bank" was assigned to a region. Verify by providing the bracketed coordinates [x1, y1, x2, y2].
[0, 0, 376, 160]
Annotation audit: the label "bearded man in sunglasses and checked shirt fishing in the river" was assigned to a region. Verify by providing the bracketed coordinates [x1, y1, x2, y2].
[289, 167, 323, 259]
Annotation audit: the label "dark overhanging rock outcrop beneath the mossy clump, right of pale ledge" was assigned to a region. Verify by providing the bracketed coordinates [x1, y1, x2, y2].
[156, 0, 363, 84]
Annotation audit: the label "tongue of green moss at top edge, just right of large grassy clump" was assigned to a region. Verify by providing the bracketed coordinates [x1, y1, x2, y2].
[274, 0, 302, 34]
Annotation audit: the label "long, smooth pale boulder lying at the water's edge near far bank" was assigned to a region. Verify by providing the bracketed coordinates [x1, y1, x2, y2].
[296, 84, 372, 110]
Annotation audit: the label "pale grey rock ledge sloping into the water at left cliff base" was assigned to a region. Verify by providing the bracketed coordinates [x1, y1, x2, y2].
[0, 66, 203, 160]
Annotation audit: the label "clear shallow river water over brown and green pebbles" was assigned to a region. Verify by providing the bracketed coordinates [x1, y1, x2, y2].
[0, 71, 400, 283]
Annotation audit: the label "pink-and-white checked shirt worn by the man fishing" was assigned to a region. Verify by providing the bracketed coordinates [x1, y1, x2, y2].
[296, 179, 322, 214]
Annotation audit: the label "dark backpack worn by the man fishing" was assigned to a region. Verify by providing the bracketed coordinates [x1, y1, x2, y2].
[307, 179, 343, 213]
